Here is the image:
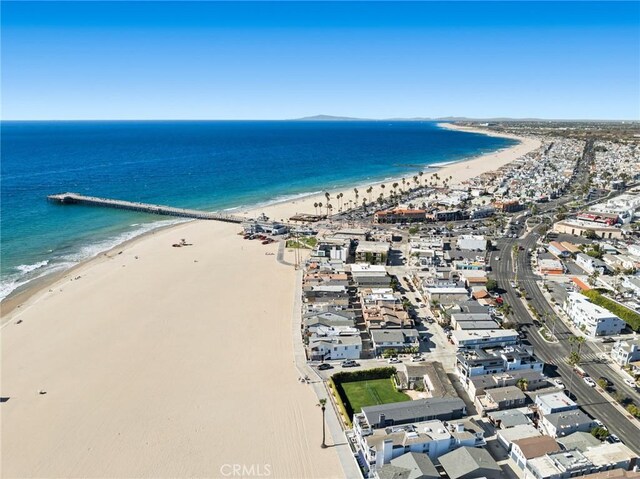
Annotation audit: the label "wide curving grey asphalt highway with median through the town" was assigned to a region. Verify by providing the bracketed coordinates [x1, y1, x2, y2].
[490, 228, 640, 454]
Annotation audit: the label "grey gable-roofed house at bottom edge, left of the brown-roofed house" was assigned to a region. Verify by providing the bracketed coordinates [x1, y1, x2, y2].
[440, 447, 504, 479]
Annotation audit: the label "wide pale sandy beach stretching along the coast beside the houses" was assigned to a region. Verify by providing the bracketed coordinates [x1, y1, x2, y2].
[0, 125, 539, 478]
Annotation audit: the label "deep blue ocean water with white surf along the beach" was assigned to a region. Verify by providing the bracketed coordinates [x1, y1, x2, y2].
[0, 121, 515, 298]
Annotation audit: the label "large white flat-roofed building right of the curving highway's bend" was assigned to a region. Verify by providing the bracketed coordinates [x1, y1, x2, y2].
[564, 293, 625, 337]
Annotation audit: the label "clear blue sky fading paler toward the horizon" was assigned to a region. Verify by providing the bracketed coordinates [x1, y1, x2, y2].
[1, 1, 640, 119]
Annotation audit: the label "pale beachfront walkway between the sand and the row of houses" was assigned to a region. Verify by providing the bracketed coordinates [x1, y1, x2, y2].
[291, 269, 362, 478]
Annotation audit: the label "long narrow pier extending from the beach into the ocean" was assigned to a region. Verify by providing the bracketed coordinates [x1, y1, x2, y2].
[47, 193, 248, 223]
